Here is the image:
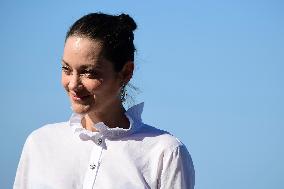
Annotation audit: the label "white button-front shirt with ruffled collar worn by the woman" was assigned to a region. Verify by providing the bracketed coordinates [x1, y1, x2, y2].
[14, 103, 194, 189]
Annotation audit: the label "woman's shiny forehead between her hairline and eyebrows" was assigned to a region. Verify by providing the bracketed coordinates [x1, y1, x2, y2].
[63, 36, 102, 67]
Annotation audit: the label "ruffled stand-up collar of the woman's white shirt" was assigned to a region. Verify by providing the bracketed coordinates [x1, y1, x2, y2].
[69, 102, 144, 140]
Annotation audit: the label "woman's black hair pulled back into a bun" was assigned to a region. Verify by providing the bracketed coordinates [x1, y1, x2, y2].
[65, 13, 137, 72]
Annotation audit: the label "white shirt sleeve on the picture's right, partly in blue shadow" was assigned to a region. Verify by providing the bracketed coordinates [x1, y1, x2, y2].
[159, 145, 195, 189]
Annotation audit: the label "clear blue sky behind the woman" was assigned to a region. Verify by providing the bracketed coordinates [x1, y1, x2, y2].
[0, 0, 284, 189]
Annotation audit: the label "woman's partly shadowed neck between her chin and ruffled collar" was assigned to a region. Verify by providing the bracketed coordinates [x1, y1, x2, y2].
[82, 103, 129, 132]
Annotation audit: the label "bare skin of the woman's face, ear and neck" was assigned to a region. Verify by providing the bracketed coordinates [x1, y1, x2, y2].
[61, 36, 134, 131]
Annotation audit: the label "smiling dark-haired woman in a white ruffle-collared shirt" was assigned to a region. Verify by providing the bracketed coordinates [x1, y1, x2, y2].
[14, 13, 194, 189]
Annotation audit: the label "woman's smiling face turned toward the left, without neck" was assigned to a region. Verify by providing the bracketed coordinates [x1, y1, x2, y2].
[61, 36, 123, 114]
